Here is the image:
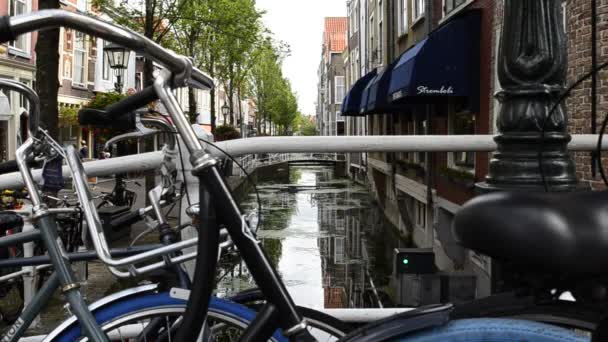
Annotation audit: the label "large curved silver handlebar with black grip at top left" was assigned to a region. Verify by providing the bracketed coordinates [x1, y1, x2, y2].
[0, 9, 214, 88]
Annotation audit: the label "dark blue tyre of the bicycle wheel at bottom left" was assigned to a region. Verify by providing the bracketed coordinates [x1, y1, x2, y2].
[52, 292, 288, 342]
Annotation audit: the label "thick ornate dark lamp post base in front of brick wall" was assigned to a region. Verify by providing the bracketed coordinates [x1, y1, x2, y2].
[478, 0, 578, 191]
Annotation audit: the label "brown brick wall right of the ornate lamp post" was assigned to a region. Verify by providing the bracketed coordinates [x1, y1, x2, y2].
[566, 0, 608, 189]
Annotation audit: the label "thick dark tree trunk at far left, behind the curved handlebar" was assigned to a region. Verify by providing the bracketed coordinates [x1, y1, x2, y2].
[36, 0, 59, 140]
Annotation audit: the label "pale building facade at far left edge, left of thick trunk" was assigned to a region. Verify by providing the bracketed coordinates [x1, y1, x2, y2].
[0, 0, 38, 162]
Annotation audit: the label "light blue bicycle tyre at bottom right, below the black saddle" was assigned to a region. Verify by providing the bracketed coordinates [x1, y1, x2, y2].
[394, 318, 589, 342]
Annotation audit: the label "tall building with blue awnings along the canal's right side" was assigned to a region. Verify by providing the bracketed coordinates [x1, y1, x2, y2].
[346, 0, 497, 296]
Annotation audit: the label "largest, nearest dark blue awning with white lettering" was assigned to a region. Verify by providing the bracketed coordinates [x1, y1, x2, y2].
[386, 10, 481, 107]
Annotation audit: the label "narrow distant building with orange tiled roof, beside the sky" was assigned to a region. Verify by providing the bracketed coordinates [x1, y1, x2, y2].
[317, 17, 347, 135]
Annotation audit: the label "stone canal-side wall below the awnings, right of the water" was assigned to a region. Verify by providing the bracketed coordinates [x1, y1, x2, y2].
[348, 162, 482, 304]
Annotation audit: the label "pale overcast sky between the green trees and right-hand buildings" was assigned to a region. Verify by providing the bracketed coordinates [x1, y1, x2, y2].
[257, 0, 346, 115]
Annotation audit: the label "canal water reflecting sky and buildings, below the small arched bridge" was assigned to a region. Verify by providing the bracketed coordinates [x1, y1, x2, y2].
[218, 166, 407, 308]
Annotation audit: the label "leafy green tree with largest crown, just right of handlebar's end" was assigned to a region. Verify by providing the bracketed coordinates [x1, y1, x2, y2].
[168, 0, 263, 132]
